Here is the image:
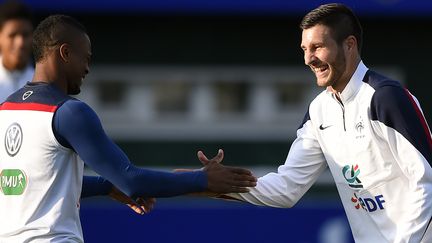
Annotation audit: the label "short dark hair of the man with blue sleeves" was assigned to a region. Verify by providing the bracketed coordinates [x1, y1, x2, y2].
[33, 14, 87, 62]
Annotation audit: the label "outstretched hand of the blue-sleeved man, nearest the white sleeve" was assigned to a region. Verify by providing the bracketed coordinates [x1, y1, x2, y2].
[203, 158, 257, 194]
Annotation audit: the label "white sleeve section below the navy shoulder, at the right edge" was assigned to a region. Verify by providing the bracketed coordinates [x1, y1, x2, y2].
[374, 122, 432, 242]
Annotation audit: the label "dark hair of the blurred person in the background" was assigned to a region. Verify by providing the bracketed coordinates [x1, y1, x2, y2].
[0, 0, 33, 29]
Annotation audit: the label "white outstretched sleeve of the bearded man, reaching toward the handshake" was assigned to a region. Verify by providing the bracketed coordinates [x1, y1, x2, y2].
[226, 120, 327, 207]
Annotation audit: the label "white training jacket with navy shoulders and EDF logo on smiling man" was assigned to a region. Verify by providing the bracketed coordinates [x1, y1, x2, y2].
[228, 62, 432, 243]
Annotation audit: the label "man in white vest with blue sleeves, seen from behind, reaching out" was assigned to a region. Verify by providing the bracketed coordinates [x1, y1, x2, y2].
[0, 15, 256, 242]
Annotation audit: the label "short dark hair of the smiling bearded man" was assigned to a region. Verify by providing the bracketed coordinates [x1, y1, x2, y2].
[300, 3, 363, 53]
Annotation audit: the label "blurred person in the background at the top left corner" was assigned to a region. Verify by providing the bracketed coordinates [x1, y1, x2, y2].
[0, 1, 34, 103]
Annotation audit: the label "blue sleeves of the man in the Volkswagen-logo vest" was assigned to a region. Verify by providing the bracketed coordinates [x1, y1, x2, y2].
[53, 99, 207, 198]
